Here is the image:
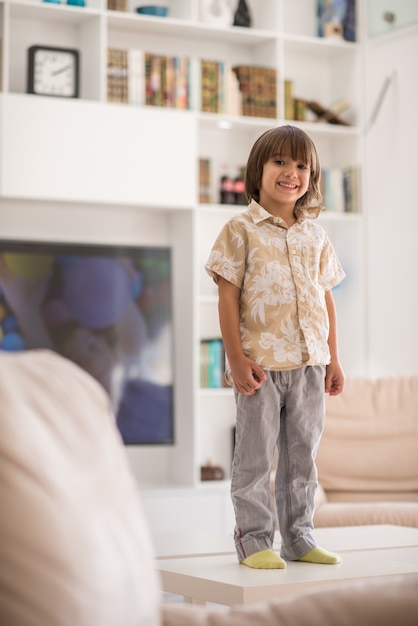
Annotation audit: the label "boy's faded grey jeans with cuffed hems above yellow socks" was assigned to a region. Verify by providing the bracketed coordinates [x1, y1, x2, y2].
[231, 365, 325, 561]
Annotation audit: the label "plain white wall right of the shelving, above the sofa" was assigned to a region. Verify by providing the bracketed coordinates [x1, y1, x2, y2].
[364, 26, 418, 376]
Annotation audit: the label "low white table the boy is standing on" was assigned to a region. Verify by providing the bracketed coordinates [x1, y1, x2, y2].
[156, 525, 418, 606]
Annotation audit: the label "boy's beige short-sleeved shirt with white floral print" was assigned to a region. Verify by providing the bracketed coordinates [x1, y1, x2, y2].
[205, 200, 345, 382]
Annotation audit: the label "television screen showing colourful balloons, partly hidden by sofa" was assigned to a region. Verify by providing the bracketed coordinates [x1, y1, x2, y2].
[0, 241, 174, 444]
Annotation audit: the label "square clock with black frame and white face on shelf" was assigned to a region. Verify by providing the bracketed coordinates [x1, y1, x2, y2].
[28, 46, 80, 98]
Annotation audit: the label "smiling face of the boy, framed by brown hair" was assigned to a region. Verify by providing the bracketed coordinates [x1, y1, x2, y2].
[260, 155, 311, 215]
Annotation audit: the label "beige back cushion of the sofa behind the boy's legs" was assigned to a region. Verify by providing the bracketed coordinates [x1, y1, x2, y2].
[317, 376, 418, 500]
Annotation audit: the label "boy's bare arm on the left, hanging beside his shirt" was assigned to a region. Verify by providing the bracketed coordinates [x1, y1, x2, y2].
[218, 276, 266, 396]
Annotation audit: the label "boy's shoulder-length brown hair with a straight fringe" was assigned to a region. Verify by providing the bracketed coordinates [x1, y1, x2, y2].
[245, 125, 322, 210]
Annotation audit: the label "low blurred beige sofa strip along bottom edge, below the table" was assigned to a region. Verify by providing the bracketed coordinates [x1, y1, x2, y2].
[163, 575, 418, 626]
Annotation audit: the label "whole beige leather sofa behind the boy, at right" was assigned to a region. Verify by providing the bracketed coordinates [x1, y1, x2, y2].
[315, 376, 418, 527]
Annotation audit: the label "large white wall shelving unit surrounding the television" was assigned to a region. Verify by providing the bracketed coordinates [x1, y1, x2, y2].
[0, 0, 365, 500]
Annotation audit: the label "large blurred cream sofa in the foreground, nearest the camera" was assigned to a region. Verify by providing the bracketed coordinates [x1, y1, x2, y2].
[0, 351, 418, 626]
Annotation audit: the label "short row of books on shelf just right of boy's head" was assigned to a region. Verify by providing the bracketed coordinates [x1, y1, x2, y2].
[321, 165, 360, 213]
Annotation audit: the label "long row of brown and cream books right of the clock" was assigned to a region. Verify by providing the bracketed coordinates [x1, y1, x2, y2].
[107, 48, 277, 118]
